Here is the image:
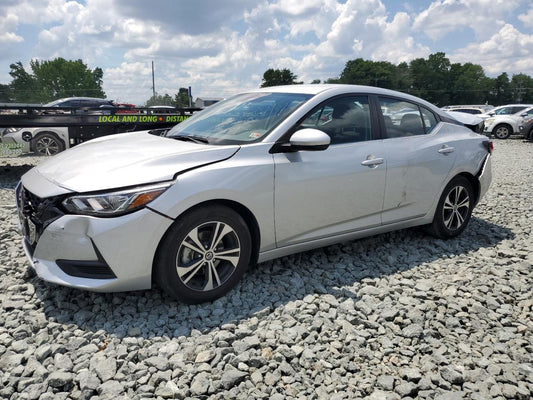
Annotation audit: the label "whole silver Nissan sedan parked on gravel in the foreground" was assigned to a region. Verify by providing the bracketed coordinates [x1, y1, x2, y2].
[17, 85, 492, 303]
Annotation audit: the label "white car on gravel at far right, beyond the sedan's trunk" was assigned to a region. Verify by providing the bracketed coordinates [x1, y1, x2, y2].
[484, 104, 533, 139]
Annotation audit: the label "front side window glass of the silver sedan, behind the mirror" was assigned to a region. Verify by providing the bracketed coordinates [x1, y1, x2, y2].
[301, 96, 372, 144]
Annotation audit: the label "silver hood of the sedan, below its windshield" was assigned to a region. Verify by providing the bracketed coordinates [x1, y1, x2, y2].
[22, 132, 240, 197]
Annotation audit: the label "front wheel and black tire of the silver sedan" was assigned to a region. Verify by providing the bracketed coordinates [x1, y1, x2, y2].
[154, 205, 252, 304]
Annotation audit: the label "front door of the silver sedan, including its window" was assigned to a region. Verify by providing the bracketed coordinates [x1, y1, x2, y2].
[274, 95, 386, 247]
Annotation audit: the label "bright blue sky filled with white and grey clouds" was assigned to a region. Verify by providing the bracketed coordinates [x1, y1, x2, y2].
[0, 0, 533, 105]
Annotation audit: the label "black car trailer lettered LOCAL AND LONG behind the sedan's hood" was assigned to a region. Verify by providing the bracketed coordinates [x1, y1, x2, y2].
[0, 103, 202, 156]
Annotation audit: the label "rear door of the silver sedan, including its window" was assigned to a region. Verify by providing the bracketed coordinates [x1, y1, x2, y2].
[379, 97, 456, 225]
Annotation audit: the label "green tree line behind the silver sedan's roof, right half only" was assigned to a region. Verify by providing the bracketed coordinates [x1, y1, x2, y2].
[261, 52, 533, 106]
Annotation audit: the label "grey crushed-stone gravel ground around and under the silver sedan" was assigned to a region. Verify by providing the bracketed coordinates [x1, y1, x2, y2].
[0, 139, 533, 400]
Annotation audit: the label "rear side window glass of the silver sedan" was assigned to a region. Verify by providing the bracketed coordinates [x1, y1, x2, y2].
[379, 97, 438, 138]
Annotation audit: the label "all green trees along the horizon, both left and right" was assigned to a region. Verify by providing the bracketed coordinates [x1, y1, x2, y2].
[0, 52, 533, 107]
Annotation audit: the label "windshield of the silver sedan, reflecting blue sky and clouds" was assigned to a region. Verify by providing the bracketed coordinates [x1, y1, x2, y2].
[166, 92, 312, 144]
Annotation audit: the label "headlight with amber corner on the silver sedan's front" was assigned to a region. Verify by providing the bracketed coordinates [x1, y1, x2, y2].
[62, 183, 171, 217]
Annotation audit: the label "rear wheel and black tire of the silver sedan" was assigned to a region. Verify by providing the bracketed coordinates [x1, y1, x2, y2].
[427, 176, 475, 239]
